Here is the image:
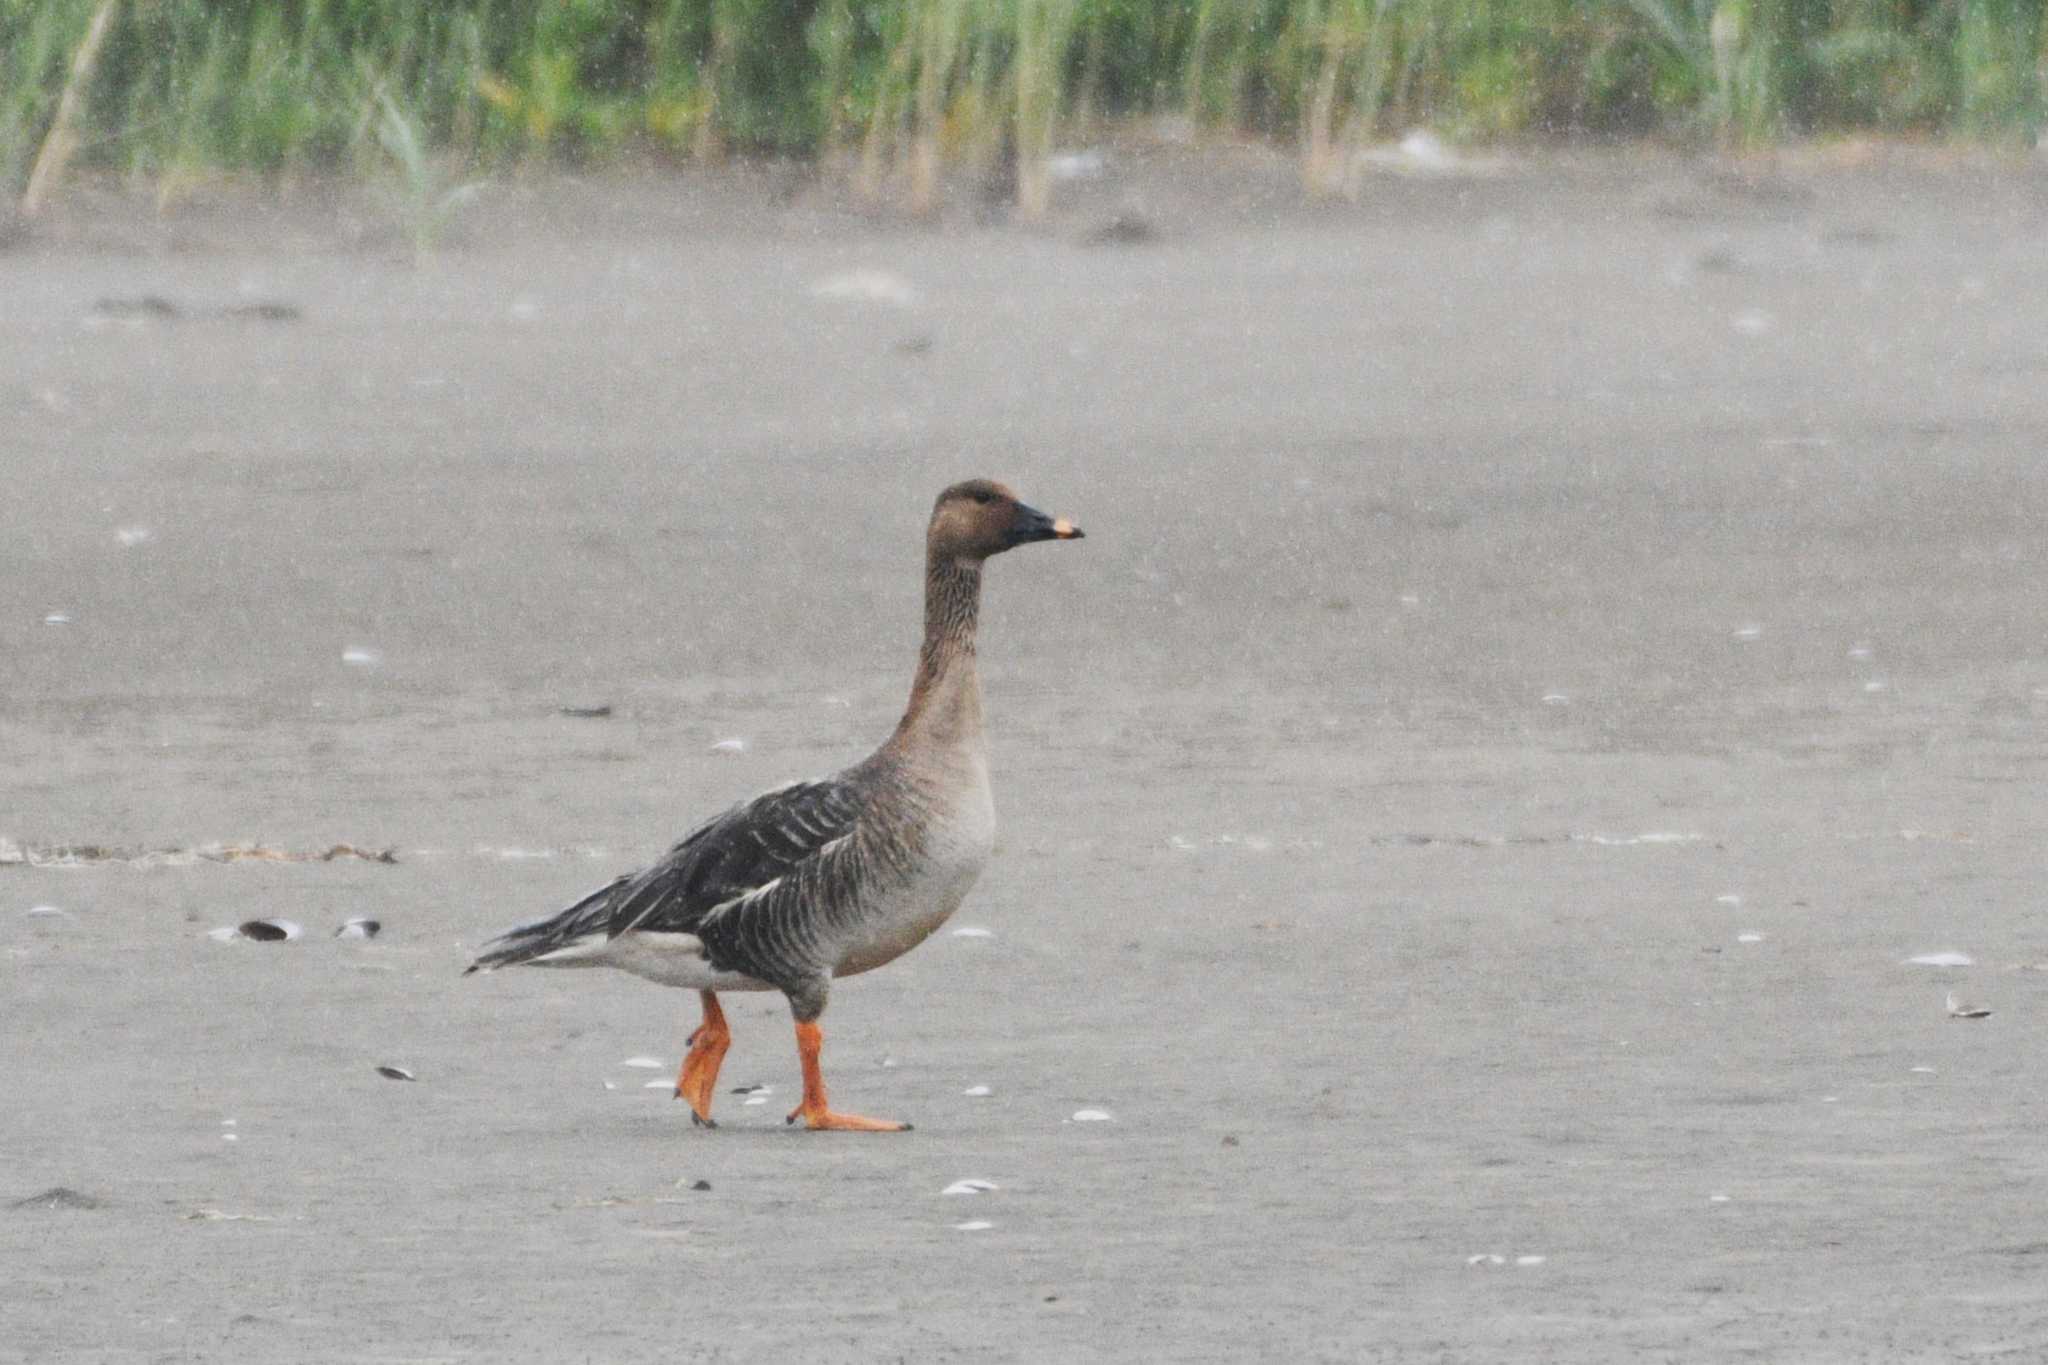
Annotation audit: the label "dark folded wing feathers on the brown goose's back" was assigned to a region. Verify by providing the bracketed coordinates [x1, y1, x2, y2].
[608, 778, 864, 937]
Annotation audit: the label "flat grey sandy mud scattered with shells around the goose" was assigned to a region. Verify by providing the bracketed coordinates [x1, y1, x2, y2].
[0, 144, 2048, 1363]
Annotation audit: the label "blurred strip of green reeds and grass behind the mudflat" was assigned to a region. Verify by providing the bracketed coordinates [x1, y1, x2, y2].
[0, 0, 2042, 209]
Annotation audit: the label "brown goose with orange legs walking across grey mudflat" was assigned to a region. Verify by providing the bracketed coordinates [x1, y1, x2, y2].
[465, 479, 1081, 1132]
